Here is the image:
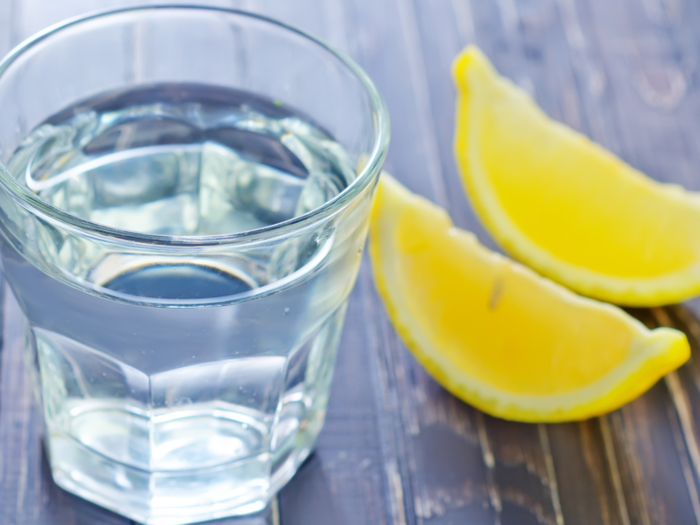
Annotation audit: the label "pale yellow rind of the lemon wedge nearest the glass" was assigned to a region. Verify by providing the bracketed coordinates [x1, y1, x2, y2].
[369, 178, 690, 422]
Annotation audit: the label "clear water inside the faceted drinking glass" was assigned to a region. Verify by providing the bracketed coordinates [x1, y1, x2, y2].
[3, 84, 359, 523]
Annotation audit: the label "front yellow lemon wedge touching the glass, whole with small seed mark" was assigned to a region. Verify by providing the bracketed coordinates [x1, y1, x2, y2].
[369, 174, 690, 422]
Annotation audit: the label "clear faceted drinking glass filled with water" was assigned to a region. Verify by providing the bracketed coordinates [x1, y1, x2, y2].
[0, 6, 389, 524]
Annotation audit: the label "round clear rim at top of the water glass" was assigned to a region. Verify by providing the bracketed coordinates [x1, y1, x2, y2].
[0, 4, 390, 248]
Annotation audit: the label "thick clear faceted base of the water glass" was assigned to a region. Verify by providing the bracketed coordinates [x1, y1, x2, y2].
[50, 422, 315, 525]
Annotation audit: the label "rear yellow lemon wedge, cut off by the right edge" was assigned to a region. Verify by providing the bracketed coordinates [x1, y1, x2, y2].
[453, 47, 700, 306]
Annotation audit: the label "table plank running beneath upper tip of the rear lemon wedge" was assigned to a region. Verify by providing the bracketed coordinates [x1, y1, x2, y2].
[408, 0, 620, 524]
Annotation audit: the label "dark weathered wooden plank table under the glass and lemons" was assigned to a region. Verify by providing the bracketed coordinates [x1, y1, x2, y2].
[0, 0, 700, 525]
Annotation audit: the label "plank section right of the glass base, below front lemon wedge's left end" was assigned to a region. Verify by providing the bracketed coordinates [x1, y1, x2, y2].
[366, 270, 498, 524]
